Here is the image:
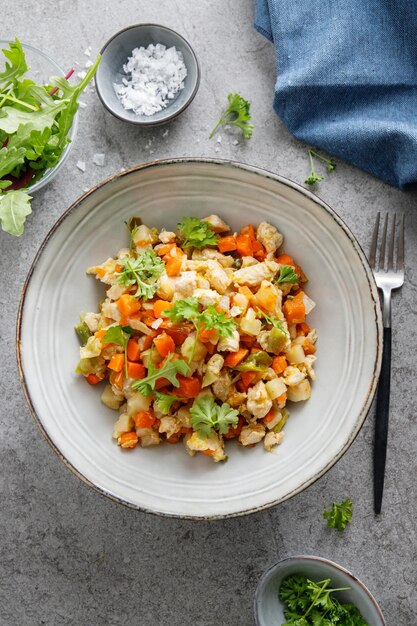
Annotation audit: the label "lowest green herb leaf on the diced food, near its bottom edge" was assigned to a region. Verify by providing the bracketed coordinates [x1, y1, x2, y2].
[190, 395, 239, 437]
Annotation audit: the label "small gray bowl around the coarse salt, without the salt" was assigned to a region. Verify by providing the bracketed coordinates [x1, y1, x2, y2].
[95, 24, 200, 126]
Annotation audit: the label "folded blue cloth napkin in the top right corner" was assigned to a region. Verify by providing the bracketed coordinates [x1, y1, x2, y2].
[255, 0, 417, 189]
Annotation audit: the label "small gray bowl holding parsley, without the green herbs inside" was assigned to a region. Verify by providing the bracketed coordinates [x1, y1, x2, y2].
[254, 556, 385, 626]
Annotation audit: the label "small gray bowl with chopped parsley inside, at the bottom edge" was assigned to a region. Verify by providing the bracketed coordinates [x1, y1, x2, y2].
[254, 556, 385, 626]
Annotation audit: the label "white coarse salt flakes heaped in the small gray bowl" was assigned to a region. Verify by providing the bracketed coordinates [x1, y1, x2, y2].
[114, 43, 187, 116]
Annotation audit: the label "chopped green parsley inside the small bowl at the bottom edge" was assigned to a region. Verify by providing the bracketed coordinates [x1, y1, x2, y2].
[279, 574, 369, 626]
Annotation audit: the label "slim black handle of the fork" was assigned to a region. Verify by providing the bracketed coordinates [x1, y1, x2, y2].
[374, 328, 391, 513]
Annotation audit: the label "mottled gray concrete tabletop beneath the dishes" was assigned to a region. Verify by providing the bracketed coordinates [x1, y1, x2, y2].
[0, 0, 417, 626]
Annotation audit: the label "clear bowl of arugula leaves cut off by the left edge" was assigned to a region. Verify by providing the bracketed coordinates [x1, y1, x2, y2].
[0, 39, 99, 236]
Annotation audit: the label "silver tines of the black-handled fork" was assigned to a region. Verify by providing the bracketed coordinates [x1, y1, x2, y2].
[369, 213, 404, 272]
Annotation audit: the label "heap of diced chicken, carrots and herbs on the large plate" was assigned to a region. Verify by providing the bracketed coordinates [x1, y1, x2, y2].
[76, 215, 317, 461]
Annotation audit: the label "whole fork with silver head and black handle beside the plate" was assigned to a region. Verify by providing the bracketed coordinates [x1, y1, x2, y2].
[369, 213, 404, 513]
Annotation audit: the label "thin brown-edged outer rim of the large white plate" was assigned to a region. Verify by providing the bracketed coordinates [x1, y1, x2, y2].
[16, 157, 383, 521]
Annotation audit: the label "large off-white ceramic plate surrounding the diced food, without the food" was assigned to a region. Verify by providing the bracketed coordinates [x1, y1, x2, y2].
[18, 159, 382, 518]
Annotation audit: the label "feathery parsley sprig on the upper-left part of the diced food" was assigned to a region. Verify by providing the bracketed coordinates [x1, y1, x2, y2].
[116, 248, 165, 300]
